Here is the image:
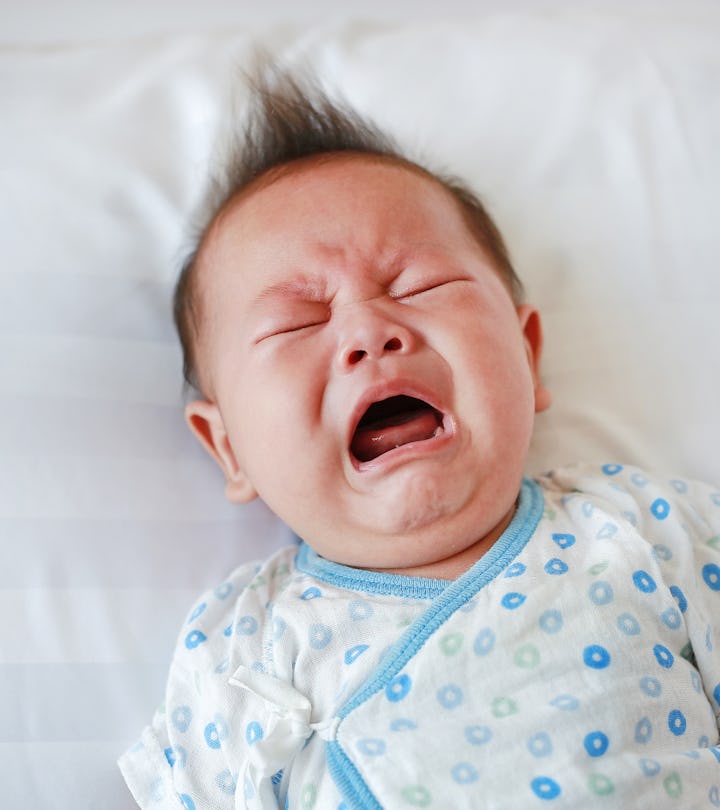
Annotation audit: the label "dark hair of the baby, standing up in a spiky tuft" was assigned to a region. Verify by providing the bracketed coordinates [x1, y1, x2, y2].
[173, 61, 522, 390]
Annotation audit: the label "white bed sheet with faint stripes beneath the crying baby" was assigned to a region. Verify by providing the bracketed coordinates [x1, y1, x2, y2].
[0, 0, 720, 810]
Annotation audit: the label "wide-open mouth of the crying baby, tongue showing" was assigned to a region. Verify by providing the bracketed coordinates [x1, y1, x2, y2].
[350, 394, 443, 462]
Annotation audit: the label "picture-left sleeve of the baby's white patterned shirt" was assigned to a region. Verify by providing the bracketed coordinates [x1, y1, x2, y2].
[118, 564, 265, 810]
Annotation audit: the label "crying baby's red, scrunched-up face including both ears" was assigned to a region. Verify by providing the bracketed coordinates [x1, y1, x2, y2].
[188, 152, 547, 569]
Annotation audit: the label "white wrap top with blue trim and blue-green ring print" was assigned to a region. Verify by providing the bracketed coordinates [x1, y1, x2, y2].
[120, 465, 720, 810]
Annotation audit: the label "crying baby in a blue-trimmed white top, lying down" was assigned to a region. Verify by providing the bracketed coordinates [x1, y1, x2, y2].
[120, 69, 720, 810]
